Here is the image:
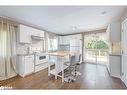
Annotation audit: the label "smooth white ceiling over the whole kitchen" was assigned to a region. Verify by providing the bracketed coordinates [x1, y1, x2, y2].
[0, 6, 127, 34]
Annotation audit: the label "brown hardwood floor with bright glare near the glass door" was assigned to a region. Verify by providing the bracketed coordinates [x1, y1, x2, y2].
[0, 64, 126, 89]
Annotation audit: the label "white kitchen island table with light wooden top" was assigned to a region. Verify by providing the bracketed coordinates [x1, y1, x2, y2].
[47, 51, 76, 82]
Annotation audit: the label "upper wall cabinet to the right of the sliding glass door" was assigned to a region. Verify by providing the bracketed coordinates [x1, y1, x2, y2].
[106, 22, 120, 42]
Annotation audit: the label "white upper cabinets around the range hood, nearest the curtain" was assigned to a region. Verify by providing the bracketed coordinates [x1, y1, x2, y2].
[17, 24, 44, 44]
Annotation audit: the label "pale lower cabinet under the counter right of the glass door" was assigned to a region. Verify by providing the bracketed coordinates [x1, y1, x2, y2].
[108, 55, 121, 78]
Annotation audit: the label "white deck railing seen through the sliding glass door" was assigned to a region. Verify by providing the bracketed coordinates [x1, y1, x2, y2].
[84, 49, 108, 64]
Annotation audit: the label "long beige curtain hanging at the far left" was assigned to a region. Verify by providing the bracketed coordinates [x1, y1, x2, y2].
[0, 20, 16, 80]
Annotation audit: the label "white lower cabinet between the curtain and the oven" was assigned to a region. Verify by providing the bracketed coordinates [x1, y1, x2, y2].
[17, 55, 34, 77]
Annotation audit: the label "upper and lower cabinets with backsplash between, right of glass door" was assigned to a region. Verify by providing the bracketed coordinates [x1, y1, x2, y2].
[106, 22, 121, 78]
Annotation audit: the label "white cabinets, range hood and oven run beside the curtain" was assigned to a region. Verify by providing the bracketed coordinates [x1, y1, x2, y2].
[17, 25, 48, 77]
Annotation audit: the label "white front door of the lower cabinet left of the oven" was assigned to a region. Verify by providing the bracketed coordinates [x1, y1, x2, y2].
[24, 56, 34, 75]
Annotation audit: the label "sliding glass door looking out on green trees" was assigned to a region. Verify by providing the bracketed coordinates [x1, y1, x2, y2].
[84, 33, 108, 64]
